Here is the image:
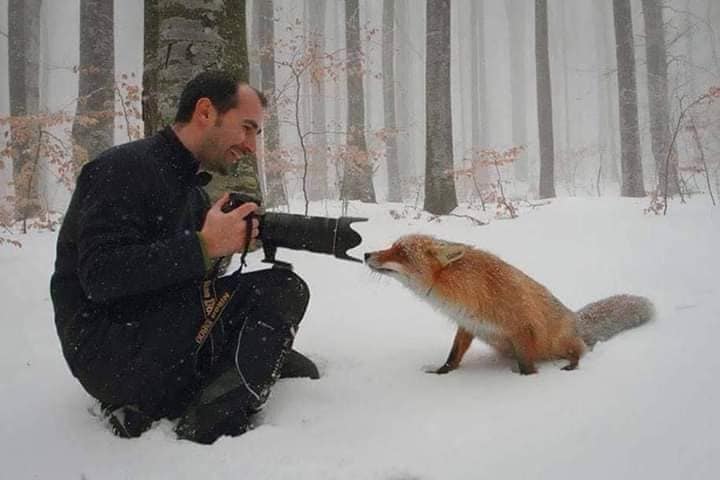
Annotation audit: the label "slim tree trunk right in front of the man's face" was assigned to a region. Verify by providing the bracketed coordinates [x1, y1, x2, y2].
[255, 0, 288, 207]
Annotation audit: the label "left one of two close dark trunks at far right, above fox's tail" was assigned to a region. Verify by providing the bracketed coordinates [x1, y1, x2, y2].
[613, 0, 645, 197]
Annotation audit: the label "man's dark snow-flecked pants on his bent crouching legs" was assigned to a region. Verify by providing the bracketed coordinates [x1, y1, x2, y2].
[79, 269, 309, 419]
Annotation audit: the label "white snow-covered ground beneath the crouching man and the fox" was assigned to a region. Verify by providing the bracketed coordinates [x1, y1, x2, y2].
[0, 197, 720, 480]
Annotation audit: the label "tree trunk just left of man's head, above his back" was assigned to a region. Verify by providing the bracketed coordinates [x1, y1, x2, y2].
[72, 0, 114, 172]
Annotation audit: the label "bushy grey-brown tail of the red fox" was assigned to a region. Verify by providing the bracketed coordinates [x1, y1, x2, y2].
[577, 295, 655, 347]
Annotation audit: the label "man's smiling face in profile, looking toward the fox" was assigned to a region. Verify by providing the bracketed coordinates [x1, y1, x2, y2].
[197, 85, 263, 175]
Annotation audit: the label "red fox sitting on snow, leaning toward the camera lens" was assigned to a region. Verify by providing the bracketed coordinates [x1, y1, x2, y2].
[365, 235, 654, 375]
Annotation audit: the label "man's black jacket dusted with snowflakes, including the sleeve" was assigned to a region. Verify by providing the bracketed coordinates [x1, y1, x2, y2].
[50, 128, 209, 382]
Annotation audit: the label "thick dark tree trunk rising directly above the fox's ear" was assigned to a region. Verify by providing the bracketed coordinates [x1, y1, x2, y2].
[424, 0, 457, 215]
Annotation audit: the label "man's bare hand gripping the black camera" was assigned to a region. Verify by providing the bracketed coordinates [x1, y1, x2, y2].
[200, 193, 260, 258]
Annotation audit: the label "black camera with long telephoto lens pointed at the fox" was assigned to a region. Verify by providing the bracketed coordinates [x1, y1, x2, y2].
[222, 192, 367, 268]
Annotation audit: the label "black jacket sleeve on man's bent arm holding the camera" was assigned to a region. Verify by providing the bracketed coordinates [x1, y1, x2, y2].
[76, 158, 205, 303]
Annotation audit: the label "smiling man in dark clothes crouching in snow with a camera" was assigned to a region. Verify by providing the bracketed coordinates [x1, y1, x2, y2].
[50, 72, 317, 443]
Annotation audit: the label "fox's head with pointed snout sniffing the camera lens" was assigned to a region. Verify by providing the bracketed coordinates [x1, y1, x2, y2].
[365, 235, 469, 284]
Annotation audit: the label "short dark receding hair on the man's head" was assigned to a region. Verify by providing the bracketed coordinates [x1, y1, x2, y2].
[175, 71, 267, 123]
